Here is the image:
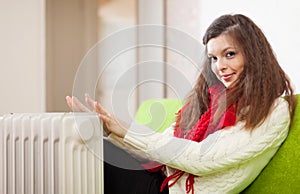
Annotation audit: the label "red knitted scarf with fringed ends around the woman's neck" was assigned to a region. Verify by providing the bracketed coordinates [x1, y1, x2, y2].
[161, 85, 236, 193]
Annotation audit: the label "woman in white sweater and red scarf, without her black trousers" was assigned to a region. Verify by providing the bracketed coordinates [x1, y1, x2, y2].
[67, 14, 295, 193]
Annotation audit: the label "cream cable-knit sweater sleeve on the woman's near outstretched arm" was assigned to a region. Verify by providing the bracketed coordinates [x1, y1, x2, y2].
[124, 98, 290, 176]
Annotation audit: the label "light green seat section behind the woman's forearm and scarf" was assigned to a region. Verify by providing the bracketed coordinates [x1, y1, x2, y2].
[135, 99, 182, 133]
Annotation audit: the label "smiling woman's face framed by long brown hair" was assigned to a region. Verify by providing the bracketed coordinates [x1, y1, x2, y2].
[207, 34, 245, 88]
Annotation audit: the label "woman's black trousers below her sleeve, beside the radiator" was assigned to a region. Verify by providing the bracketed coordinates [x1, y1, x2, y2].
[104, 140, 169, 194]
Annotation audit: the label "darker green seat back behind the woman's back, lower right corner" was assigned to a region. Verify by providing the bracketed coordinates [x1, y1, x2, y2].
[242, 94, 300, 194]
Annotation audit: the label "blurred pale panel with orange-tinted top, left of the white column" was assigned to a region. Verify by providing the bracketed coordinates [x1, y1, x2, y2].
[93, 0, 137, 122]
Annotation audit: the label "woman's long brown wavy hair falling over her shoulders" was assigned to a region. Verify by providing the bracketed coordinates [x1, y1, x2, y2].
[178, 14, 295, 131]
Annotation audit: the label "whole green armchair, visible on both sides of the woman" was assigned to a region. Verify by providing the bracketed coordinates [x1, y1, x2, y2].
[135, 94, 300, 194]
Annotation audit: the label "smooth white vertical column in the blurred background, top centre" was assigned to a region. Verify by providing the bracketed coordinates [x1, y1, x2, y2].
[137, 0, 165, 104]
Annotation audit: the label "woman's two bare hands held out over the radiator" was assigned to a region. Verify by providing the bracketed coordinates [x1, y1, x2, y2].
[66, 94, 129, 138]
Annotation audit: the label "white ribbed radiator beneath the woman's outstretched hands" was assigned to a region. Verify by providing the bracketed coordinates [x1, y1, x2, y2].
[0, 113, 103, 194]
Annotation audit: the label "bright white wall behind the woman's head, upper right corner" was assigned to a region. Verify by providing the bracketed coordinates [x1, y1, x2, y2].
[200, 0, 300, 93]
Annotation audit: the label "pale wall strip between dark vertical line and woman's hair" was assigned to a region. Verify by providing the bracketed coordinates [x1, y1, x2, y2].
[165, 0, 204, 99]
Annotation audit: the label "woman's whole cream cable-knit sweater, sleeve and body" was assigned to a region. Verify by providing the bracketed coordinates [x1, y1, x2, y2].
[109, 98, 290, 194]
